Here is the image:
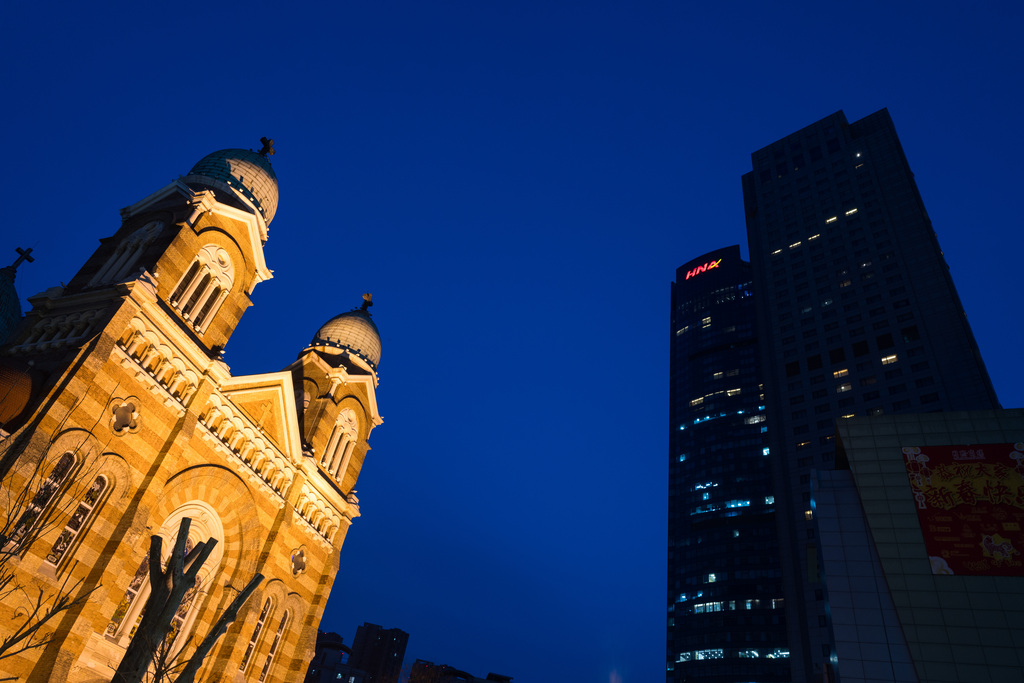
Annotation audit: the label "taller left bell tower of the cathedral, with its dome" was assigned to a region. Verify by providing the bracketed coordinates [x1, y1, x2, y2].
[24, 138, 279, 357]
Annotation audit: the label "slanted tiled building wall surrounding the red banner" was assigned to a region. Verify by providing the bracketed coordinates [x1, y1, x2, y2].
[839, 410, 1024, 683]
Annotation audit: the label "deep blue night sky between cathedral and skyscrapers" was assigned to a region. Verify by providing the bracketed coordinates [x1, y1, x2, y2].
[0, 0, 1024, 683]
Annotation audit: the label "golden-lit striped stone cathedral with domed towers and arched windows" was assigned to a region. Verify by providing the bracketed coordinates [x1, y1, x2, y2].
[0, 138, 381, 683]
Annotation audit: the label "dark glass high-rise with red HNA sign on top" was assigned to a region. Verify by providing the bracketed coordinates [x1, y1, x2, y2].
[668, 246, 790, 683]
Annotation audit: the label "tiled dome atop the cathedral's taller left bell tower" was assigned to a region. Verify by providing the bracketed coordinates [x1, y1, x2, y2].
[183, 150, 278, 224]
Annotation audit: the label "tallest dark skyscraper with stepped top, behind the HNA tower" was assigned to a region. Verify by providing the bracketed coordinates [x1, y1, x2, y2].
[742, 110, 998, 681]
